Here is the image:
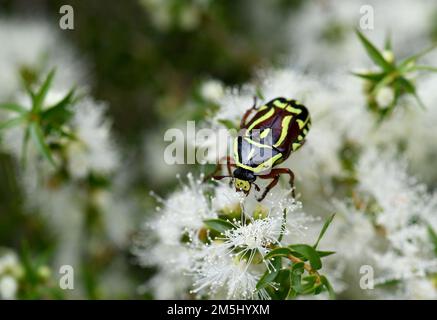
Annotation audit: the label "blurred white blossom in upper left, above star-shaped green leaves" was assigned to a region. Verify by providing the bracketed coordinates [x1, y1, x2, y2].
[0, 17, 85, 101]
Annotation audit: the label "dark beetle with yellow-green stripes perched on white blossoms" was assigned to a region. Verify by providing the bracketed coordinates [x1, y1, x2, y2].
[213, 98, 311, 201]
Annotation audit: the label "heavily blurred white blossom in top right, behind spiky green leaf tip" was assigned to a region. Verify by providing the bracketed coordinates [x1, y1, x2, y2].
[288, 0, 436, 73]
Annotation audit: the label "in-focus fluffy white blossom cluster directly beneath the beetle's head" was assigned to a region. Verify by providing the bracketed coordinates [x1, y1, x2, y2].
[134, 174, 330, 299]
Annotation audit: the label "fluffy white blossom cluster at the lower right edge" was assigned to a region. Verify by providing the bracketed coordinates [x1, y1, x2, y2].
[327, 150, 437, 298]
